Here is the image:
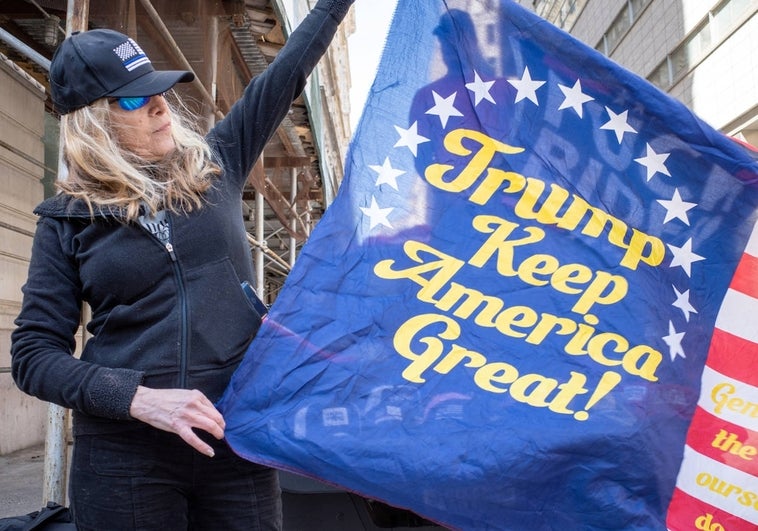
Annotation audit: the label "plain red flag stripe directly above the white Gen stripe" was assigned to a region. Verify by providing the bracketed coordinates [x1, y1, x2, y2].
[706, 330, 758, 387]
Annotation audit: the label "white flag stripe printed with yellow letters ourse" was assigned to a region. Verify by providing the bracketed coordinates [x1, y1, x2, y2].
[676, 446, 758, 525]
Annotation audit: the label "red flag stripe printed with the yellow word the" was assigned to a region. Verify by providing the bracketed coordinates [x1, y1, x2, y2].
[687, 407, 758, 476]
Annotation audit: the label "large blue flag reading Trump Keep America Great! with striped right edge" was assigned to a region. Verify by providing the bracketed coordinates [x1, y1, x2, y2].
[219, 0, 758, 530]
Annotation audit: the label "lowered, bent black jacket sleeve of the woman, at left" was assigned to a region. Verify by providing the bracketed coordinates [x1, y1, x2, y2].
[11, 218, 143, 419]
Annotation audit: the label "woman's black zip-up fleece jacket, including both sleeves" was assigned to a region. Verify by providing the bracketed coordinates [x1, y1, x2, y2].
[11, 0, 353, 434]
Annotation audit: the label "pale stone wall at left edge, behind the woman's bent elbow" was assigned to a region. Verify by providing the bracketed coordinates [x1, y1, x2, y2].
[0, 54, 47, 455]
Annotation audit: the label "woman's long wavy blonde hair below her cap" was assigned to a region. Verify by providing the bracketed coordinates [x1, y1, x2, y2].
[56, 93, 221, 220]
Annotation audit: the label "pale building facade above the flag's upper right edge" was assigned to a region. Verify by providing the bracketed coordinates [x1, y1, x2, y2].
[520, 0, 758, 145]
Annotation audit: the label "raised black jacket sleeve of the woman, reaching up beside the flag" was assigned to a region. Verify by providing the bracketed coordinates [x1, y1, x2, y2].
[208, 0, 354, 189]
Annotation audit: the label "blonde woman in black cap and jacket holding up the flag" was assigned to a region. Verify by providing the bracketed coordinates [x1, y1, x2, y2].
[12, 0, 353, 530]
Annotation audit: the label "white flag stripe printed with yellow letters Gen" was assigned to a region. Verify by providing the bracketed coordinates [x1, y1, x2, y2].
[698, 366, 758, 432]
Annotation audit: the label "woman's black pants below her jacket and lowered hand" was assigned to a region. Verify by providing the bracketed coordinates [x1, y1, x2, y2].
[70, 425, 282, 531]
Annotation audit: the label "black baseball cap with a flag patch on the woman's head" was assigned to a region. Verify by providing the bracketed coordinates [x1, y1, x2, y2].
[50, 29, 195, 114]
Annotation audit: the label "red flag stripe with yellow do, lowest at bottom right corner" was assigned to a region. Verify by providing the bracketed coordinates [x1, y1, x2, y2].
[666, 489, 755, 531]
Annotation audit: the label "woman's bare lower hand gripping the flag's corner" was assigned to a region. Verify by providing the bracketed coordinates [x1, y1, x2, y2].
[129, 385, 225, 457]
